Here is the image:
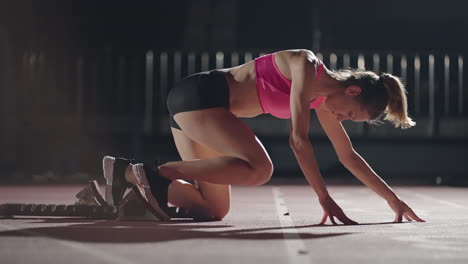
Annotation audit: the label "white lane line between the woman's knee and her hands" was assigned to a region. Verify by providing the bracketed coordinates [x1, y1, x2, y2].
[272, 187, 311, 263]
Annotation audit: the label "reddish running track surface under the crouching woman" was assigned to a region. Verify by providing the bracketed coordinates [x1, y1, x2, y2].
[0, 184, 468, 264]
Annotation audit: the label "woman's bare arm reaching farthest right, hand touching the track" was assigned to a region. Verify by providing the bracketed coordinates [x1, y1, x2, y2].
[316, 110, 424, 222]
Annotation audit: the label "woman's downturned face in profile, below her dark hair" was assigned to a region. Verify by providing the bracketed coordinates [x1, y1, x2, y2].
[325, 85, 369, 122]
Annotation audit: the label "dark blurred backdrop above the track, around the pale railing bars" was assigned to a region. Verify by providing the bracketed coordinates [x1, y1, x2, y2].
[0, 0, 468, 183]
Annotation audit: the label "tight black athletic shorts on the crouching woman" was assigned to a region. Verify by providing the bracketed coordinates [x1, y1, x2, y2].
[167, 70, 229, 130]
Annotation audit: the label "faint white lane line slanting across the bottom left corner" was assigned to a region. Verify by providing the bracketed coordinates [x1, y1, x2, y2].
[0, 224, 133, 264]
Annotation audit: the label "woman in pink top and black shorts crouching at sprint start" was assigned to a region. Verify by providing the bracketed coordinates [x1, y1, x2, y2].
[103, 50, 424, 224]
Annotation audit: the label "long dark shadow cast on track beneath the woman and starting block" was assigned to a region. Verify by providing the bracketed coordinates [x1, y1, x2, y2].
[0, 218, 353, 243]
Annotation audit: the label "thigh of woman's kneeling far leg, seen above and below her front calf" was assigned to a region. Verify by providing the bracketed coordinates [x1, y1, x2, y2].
[171, 128, 231, 207]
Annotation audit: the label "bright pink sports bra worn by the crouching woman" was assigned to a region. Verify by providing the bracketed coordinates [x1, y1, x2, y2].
[255, 53, 326, 119]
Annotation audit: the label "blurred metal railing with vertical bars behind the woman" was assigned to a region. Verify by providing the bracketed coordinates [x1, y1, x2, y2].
[8, 50, 468, 135]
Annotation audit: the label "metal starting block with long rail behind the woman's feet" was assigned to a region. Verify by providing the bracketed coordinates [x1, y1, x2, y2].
[0, 181, 192, 221]
